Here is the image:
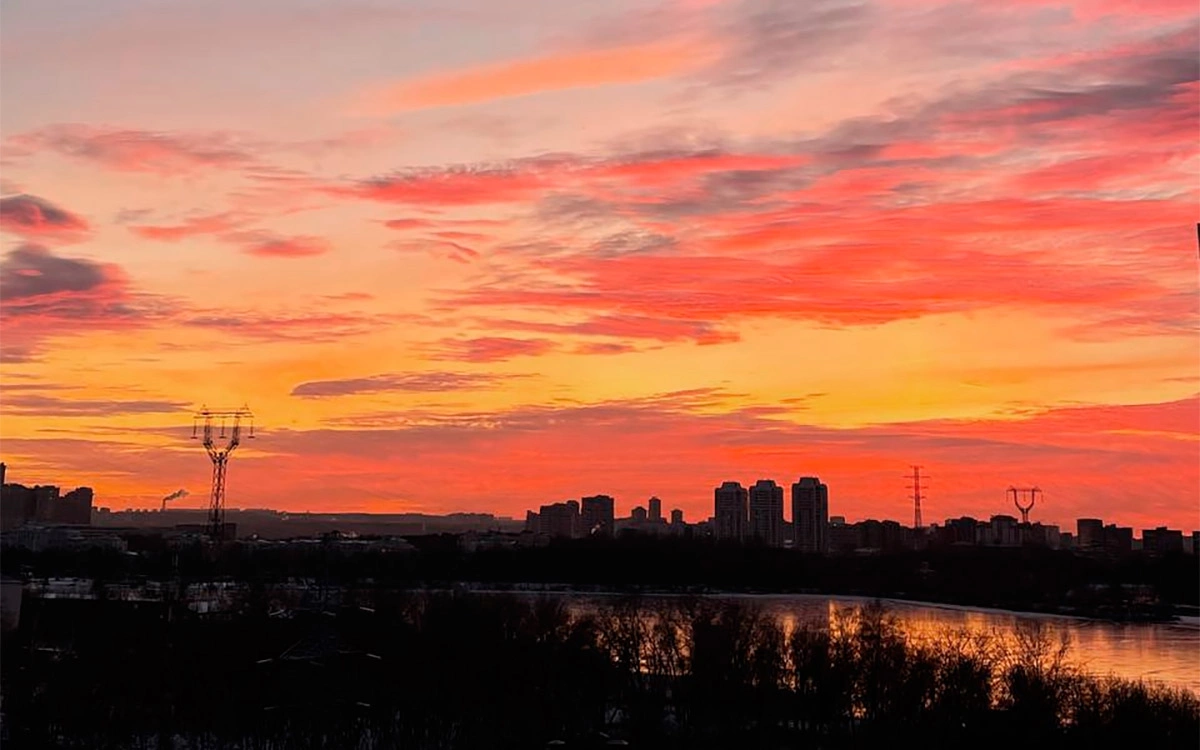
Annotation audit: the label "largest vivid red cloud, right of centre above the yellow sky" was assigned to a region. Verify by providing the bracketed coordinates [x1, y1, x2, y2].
[454, 228, 1194, 333]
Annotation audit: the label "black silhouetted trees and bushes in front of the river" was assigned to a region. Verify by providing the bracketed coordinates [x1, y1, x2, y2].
[0, 589, 1200, 750]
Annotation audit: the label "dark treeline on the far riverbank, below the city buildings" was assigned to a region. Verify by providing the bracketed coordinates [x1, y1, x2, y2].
[4, 535, 1200, 614]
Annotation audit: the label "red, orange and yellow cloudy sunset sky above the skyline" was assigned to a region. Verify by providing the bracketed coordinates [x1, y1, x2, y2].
[0, 0, 1200, 529]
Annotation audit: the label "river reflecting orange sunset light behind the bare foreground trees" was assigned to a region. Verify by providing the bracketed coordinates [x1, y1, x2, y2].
[537, 593, 1200, 695]
